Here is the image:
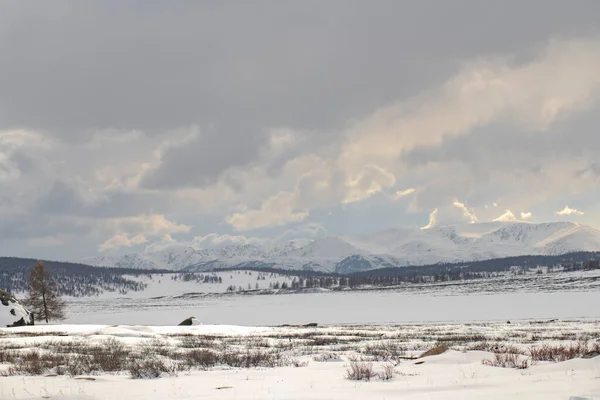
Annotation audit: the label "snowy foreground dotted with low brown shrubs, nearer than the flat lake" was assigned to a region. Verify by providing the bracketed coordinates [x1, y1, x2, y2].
[0, 319, 600, 400]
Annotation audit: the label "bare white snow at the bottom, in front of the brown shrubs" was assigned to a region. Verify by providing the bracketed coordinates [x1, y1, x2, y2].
[0, 351, 600, 400]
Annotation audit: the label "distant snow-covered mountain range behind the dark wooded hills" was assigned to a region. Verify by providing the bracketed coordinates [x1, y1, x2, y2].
[81, 222, 600, 273]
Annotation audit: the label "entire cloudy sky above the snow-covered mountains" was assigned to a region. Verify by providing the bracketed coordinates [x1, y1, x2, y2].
[0, 0, 600, 261]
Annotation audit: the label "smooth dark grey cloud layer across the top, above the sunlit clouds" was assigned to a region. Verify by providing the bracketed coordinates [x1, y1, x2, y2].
[0, 1, 600, 138]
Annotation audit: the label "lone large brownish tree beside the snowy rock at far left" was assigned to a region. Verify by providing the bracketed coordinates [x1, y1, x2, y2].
[25, 261, 65, 323]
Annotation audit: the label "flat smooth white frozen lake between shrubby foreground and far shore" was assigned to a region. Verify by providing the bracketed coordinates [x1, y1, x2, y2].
[64, 290, 600, 325]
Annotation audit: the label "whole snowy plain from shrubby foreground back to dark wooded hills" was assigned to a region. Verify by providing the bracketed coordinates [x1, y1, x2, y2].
[0, 271, 600, 400]
